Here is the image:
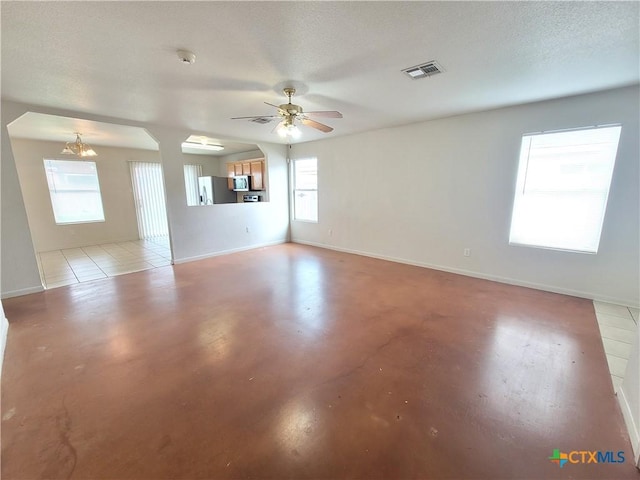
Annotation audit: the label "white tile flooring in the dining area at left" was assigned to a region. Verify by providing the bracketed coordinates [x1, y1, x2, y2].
[36, 237, 171, 289]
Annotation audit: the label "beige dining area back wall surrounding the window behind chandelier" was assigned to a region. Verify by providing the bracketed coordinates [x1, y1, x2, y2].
[11, 138, 160, 252]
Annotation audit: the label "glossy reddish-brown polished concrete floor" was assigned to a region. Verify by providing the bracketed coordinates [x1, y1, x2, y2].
[1, 244, 640, 479]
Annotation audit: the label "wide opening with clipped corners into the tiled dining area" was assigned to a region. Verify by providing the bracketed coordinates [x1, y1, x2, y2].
[7, 112, 172, 289]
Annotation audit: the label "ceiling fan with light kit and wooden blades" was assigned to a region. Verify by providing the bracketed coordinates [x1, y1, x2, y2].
[231, 87, 342, 138]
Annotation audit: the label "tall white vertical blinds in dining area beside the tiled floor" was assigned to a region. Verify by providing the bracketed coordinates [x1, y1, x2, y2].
[129, 162, 169, 239]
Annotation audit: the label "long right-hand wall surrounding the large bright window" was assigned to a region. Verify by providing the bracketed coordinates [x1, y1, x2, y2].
[291, 86, 640, 306]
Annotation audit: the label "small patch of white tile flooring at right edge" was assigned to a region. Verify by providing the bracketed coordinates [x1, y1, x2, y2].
[593, 302, 640, 392]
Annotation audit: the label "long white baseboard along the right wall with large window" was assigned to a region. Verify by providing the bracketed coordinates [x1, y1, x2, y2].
[291, 238, 638, 308]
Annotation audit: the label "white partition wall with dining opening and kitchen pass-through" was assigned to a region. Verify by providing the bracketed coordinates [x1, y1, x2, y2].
[0, 101, 289, 297]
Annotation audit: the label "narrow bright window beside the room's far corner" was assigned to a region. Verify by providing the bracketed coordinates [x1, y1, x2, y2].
[293, 158, 318, 222]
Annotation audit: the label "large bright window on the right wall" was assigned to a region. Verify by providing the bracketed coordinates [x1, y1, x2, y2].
[509, 125, 622, 253]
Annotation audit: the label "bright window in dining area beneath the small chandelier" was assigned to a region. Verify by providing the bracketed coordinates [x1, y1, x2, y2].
[44, 159, 104, 225]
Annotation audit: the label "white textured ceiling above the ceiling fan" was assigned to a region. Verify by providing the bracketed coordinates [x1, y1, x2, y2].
[1, 1, 640, 147]
